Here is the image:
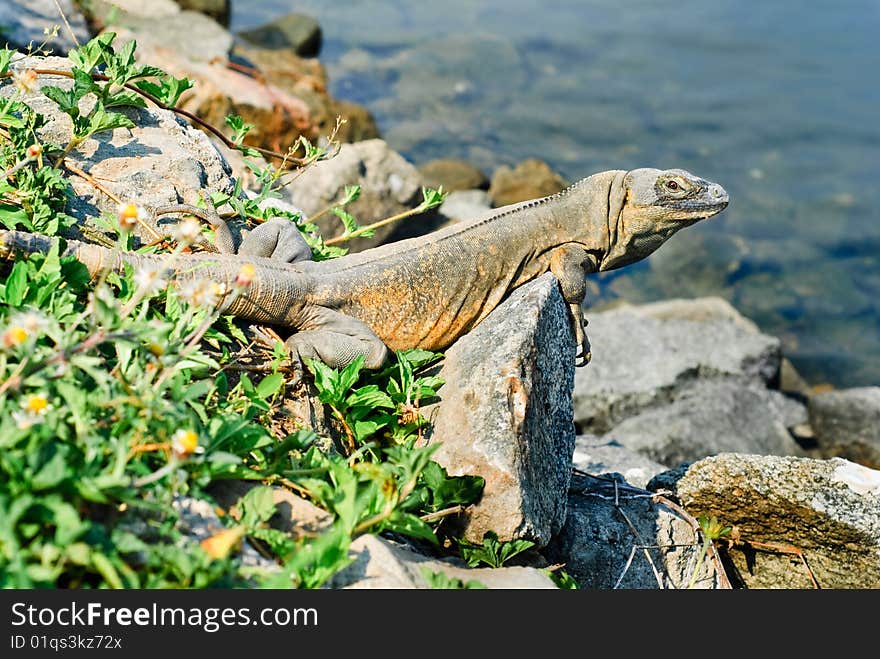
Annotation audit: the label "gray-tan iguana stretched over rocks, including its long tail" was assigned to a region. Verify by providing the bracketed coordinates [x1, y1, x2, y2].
[0, 169, 728, 368]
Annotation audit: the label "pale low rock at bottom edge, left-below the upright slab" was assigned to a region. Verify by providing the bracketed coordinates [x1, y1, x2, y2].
[324, 535, 556, 589]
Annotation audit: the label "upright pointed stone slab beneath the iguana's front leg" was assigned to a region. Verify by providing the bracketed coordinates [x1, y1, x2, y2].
[425, 274, 575, 547]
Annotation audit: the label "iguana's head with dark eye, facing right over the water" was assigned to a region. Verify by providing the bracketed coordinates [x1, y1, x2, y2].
[599, 168, 729, 270]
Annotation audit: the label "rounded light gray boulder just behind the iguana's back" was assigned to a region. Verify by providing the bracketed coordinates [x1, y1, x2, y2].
[281, 139, 422, 251]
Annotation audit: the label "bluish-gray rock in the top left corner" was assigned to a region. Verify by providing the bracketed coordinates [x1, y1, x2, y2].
[0, 0, 91, 55]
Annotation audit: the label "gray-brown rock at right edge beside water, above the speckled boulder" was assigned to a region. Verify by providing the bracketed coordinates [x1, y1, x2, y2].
[808, 387, 880, 469]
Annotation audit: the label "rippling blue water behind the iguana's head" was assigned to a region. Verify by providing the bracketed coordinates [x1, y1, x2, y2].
[232, 0, 880, 386]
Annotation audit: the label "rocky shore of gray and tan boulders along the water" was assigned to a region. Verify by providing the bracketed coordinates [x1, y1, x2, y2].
[6, 0, 880, 589]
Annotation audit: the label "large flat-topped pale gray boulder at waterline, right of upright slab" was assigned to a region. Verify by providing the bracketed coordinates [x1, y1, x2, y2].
[574, 298, 781, 434]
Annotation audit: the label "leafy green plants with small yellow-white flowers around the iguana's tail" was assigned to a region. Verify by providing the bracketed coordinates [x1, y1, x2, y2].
[0, 33, 484, 588]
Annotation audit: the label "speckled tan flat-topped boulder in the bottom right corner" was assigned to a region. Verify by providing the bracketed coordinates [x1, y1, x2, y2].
[676, 454, 880, 589]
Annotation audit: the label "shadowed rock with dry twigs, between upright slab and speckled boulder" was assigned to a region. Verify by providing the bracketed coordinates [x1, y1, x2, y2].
[545, 478, 723, 590]
